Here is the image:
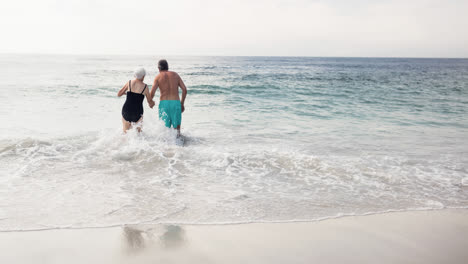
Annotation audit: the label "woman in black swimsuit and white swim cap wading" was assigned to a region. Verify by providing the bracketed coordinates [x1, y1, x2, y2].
[117, 68, 155, 133]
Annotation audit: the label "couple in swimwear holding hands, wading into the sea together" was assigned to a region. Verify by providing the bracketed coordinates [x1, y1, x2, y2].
[117, 60, 187, 137]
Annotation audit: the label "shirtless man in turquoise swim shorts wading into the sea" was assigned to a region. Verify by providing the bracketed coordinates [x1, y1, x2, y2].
[150, 60, 187, 137]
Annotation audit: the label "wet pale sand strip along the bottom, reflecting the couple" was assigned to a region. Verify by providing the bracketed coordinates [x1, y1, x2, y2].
[0, 209, 468, 264]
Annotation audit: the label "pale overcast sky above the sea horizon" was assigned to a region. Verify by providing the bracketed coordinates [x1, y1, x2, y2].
[0, 0, 468, 57]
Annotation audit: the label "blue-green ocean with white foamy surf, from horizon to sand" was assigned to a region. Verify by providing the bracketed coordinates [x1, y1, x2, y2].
[0, 55, 468, 231]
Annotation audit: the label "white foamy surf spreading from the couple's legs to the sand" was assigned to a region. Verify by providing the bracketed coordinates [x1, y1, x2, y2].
[0, 123, 466, 230]
